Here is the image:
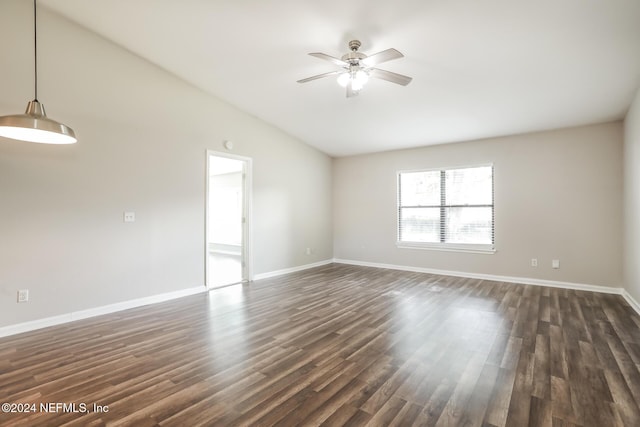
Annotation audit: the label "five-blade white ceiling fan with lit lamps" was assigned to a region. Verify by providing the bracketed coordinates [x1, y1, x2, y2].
[298, 40, 411, 98]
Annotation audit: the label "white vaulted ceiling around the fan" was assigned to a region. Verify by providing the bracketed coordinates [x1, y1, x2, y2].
[40, 0, 640, 156]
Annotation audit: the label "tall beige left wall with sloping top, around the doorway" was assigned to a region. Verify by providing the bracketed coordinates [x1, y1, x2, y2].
[0, 0, 332, 327]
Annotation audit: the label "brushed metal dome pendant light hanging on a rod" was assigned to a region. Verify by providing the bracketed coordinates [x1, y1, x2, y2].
[0, 0, 77, 144]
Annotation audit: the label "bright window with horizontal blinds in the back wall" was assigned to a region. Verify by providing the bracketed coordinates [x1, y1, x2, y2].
[398, 166, 494, 252]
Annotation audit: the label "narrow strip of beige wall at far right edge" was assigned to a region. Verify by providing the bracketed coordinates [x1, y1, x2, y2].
[624, 86, 640, 301]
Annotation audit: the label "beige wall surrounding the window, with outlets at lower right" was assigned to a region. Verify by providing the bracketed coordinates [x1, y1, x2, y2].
[333, 122, 623, 287]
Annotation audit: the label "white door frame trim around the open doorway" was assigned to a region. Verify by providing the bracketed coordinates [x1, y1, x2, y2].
[204, 150, 253, 289]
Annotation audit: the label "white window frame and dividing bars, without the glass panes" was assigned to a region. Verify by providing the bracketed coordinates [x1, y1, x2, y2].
[396, 163, 496, 254]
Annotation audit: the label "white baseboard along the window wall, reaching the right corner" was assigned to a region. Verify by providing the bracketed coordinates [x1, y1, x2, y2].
[333, 259, 640, 296]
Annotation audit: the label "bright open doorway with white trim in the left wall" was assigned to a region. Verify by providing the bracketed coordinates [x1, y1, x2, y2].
[205, 151, 251, 289]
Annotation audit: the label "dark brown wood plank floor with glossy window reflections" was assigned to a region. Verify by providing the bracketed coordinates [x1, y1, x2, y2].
[0, 264, 640, 427]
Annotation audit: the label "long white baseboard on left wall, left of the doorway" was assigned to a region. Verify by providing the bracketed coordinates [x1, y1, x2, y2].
[0, 286, 207, 337]
